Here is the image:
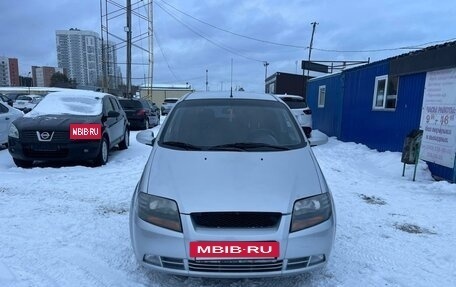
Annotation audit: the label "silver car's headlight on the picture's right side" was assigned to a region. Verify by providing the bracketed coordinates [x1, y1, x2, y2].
[290, 193, 332, 232]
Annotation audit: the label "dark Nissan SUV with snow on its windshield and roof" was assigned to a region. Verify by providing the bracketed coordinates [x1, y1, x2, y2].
[8, 90, 130, 167]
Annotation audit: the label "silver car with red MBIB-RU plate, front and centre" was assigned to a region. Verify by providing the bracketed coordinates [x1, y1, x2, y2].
[130, 92, 336, 278]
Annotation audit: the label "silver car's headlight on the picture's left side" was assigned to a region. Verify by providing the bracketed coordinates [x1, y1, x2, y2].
[138, 192, 182, 232]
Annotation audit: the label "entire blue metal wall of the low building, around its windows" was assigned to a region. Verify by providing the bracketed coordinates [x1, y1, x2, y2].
[307, 60, 456, 182]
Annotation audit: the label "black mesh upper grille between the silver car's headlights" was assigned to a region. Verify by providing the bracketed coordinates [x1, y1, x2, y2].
[191, 212, 282, 228]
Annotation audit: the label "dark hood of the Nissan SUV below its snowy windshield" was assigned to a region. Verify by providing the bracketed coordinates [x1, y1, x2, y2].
[14, 115, 100, 131]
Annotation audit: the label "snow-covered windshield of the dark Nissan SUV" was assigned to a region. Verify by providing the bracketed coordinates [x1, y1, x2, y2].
[26, 93, 103, 117]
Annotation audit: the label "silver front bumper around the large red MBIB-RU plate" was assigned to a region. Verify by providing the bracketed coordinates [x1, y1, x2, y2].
[130, 193, 335, 278]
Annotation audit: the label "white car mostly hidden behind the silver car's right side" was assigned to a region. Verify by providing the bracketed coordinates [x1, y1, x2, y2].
[277, 95, 312, 138]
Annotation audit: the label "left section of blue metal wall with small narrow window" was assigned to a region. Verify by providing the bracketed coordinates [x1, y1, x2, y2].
[307, 74, 343, 138]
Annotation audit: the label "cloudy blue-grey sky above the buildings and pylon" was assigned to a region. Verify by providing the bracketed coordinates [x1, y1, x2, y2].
[0, 0, 456, 92]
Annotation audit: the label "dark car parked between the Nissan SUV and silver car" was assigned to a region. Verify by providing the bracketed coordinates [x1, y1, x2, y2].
[119, 99, 160, 129]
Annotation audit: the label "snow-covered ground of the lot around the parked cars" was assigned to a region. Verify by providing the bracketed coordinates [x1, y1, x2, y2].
[0, 124, 456, 287]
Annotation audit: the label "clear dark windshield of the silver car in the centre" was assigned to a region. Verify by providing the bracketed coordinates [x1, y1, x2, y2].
[158, 99, 306, 151]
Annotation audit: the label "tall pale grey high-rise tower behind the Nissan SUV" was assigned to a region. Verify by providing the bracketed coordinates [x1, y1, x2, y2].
[56, 28, 117, 88]
